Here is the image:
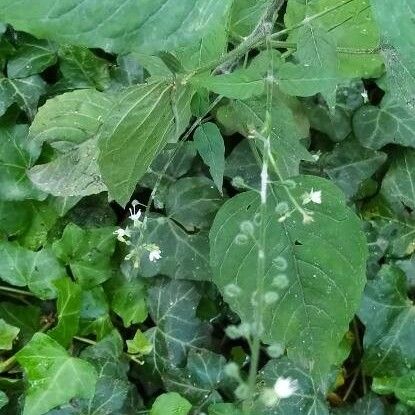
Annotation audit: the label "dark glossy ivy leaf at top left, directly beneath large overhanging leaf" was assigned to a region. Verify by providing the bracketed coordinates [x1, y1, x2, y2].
[7, 34, 57, 78]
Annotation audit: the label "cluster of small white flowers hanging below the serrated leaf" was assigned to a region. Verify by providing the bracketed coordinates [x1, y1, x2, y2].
[114, 200, 161, 268]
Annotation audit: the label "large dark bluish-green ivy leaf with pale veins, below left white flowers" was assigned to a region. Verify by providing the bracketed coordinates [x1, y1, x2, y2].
[145, 280, 210, 373]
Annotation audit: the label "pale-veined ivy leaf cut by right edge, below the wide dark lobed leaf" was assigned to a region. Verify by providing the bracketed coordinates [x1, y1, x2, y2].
[381, 148, 415, 212]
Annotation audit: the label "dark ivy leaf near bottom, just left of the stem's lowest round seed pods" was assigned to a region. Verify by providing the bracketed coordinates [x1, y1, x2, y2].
[162, 349, 226, 405]
